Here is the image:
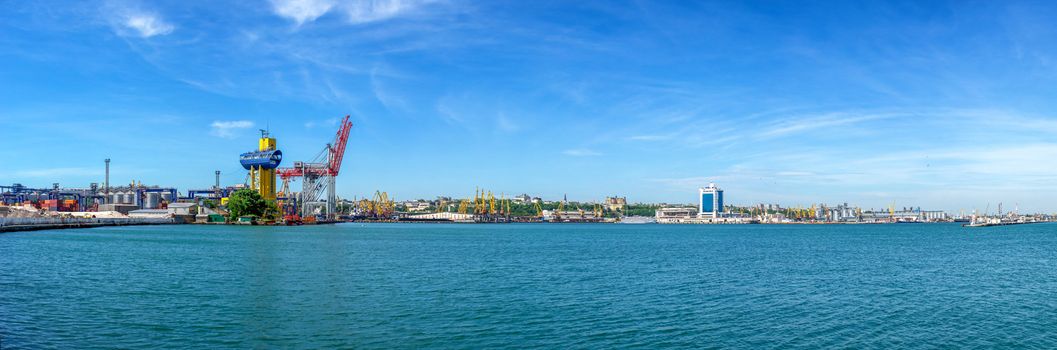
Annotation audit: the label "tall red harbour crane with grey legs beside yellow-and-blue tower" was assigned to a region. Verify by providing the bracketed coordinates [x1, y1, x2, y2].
[276, 115, 352, 220]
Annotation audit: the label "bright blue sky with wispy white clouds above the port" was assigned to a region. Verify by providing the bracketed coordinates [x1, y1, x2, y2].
[0, 0, 1057, 213]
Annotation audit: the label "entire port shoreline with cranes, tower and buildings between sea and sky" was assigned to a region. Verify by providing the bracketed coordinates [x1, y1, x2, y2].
[0, 115, 1055, 232]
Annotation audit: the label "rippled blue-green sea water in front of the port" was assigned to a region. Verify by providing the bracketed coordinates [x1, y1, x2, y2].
[0, 224, 1057, 349]
